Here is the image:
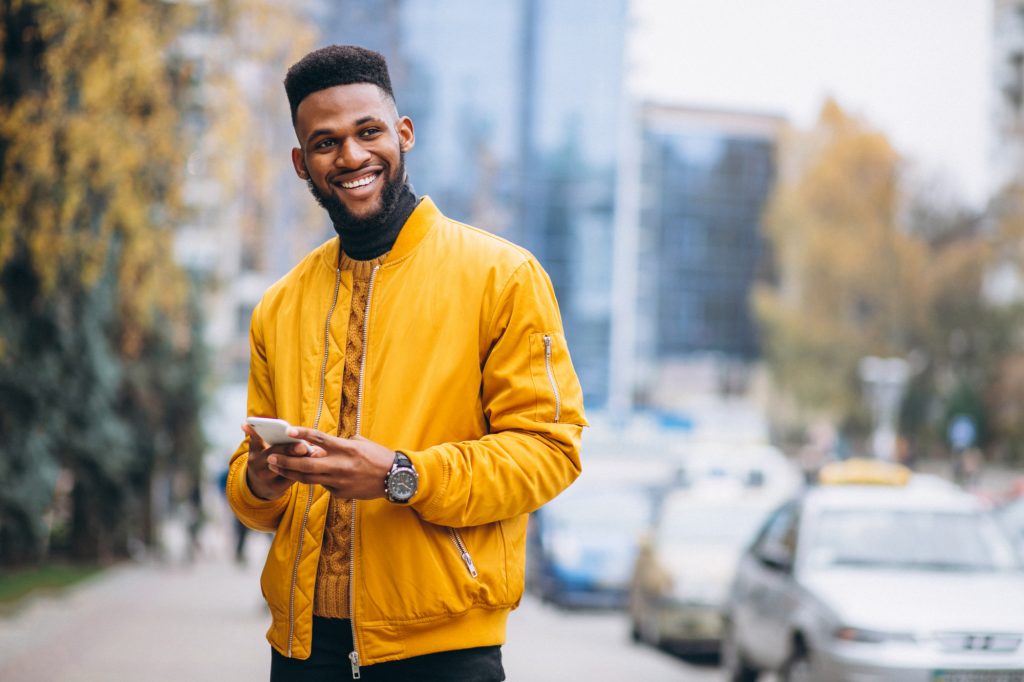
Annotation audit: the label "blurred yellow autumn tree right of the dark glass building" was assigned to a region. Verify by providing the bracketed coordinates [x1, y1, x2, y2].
[754, 101, 1021, 444]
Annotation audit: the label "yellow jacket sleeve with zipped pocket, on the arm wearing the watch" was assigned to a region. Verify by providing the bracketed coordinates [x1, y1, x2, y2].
[407, 258, 587, 527]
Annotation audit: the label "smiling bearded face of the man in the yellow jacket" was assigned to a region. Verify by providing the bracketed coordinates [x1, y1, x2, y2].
[292, 83, 416, 226]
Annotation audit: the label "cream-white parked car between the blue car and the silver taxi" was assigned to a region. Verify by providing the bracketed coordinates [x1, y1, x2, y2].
[630, 481, 779, 653]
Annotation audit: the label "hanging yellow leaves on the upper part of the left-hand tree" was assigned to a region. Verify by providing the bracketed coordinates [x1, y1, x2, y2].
[0, 0, 190, 337]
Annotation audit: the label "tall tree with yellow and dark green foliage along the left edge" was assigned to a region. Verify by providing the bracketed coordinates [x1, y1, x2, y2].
[0, 0, 201, 563]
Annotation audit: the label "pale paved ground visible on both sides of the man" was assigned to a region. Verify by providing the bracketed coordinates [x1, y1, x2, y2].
[0, 521, 723, 682]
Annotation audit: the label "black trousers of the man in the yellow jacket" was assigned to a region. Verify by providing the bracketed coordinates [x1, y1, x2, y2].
[270, 616, 505, 682]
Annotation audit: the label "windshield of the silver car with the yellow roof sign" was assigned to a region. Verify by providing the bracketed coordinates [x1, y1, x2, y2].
[808, 509, 1020, 571]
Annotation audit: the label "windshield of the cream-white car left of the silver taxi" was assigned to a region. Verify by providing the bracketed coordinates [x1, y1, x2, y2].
[657, 507, 767, 546]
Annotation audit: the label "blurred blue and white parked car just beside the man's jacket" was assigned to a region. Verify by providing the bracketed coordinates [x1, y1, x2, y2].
[526, 481, 652, 608]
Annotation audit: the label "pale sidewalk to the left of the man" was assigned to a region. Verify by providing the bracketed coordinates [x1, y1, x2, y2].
[0, 518, 270, 682]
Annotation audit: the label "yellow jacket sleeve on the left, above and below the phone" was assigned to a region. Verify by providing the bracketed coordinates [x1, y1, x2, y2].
[226, 304, 295, 532]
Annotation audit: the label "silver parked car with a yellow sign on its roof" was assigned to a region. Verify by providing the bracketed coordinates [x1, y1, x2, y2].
[722, 456, 1024, 682]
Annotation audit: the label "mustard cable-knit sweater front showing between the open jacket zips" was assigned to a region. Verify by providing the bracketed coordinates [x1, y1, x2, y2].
[313, 254, 387, 619]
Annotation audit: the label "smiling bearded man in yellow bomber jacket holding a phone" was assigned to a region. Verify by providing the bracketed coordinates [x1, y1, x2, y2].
[226, 46, 586, 682]
